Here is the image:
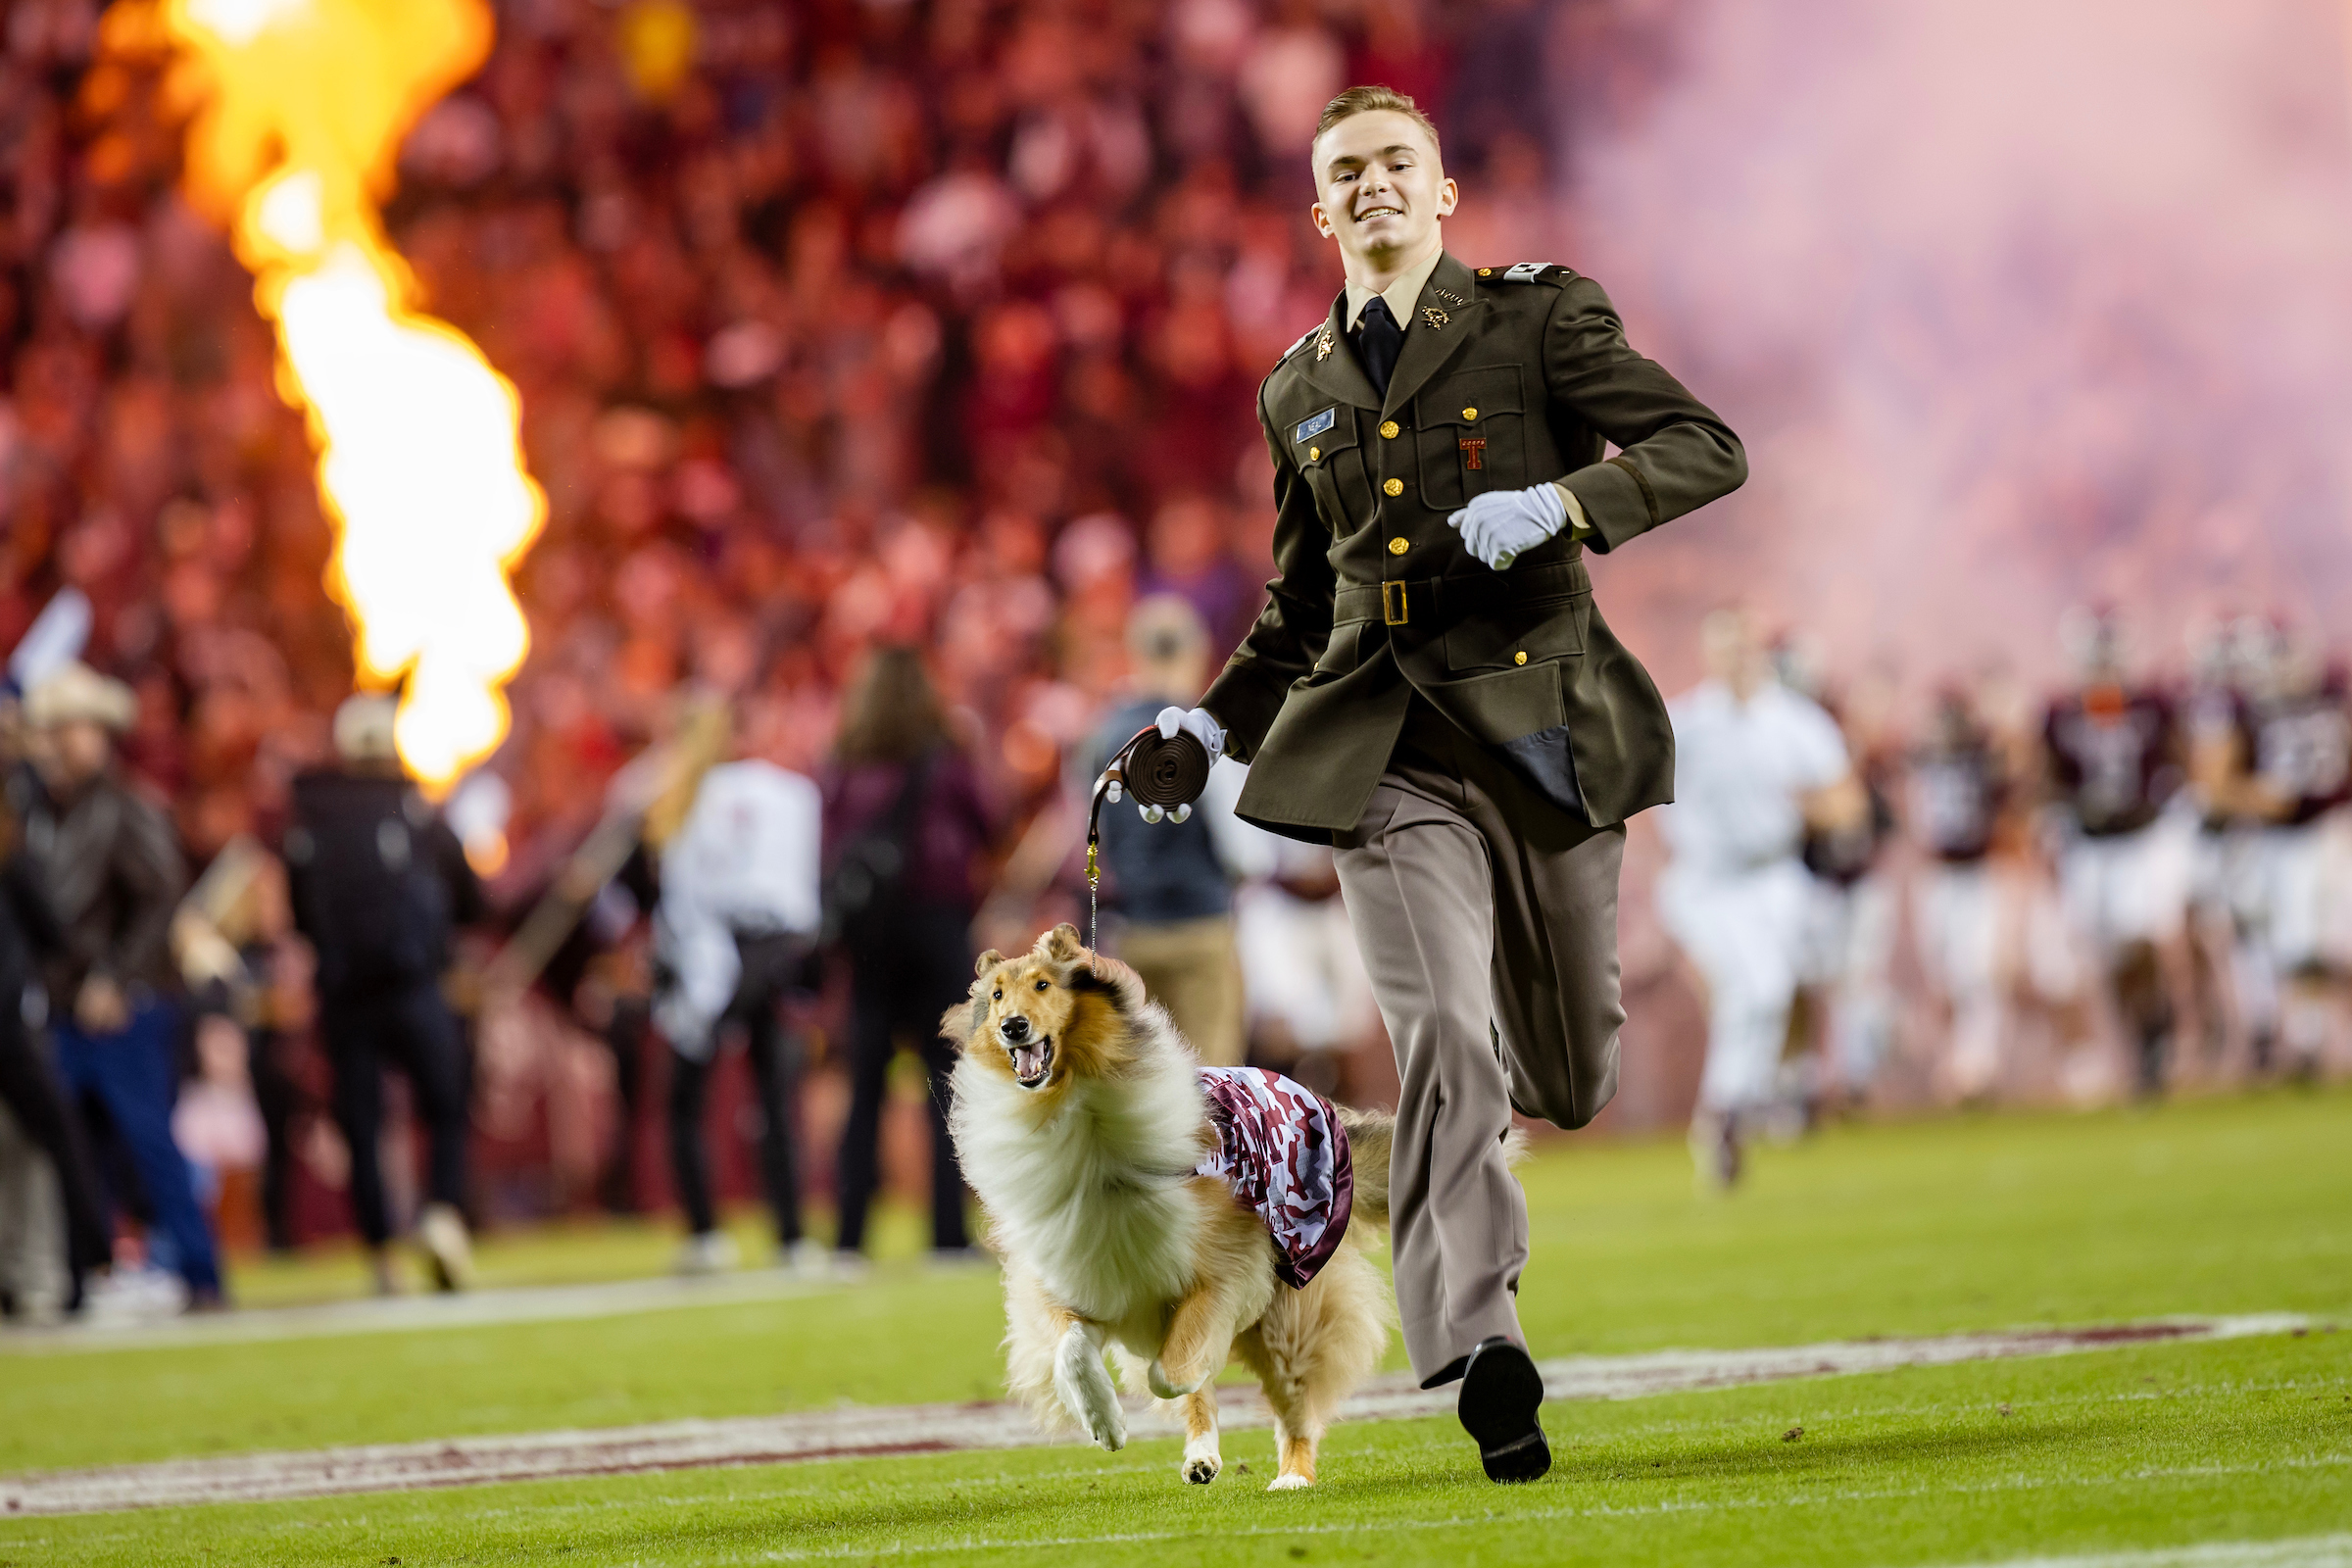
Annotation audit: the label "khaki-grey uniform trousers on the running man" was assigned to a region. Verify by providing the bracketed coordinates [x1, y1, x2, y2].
[1334, 701, 1625, 1380]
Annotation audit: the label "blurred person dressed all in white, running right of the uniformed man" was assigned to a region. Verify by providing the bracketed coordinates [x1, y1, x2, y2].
[1658, 609, 1868, 1187]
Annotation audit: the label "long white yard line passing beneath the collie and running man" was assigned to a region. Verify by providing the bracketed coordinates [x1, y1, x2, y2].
[0, 1314, 2310, 1516]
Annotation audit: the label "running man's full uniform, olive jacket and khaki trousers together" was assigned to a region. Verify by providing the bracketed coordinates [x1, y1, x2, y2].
[1201, 256, 1747, 1382]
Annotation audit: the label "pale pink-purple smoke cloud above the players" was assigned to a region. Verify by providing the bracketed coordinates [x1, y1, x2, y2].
[1566, 0, 2352, 689]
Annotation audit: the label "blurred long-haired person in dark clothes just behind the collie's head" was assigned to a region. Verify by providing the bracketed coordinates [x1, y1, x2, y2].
[825, 647, 995, 1253]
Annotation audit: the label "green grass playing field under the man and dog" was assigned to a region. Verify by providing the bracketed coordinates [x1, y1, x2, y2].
[0, 1091, 2352, 1566]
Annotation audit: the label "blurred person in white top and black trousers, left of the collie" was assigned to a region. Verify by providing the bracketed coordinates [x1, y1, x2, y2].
[654, 733, 823, 1274]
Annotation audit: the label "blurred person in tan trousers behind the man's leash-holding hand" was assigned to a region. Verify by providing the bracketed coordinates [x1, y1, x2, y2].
[1082, 597, 1249, 1067]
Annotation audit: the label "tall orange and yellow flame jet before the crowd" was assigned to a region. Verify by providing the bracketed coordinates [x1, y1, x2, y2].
[165, 0, 548, 795]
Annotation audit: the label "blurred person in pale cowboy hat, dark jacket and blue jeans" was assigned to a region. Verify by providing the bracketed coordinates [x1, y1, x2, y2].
[25, 662, 221, 1304]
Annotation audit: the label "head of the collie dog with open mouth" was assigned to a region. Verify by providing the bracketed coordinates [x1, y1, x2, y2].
[946, 924, 1122, 1093]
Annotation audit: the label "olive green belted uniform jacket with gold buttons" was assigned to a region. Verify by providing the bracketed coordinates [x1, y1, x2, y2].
[1201, 254, 1747, 842]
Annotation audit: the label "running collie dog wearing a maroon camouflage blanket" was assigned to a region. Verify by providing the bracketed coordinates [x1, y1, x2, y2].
[941, 924, 1395, 1491]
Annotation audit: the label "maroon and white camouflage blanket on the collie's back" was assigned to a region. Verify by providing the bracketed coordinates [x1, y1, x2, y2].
[1193, 1067, 1354, 1289]
